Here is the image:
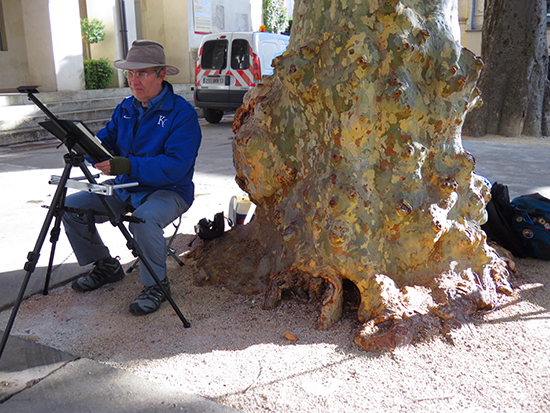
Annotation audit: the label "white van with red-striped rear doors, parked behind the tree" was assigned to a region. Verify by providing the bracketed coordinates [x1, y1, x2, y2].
[195, 32, 289, 123]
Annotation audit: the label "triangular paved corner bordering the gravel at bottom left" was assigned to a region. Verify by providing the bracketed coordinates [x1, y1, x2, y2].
[0, 337, 242, 413]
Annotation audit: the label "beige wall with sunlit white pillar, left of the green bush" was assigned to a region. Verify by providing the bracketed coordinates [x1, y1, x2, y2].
[0, 0, 84, 92]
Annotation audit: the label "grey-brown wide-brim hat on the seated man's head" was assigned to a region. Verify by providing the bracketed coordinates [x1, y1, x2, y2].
[113, 40, 180, 75]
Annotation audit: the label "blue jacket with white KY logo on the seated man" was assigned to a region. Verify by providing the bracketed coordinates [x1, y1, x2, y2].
[97, 82, 202, 206]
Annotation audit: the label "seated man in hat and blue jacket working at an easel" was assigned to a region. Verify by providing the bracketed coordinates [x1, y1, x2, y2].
[63, 40, 201, 315]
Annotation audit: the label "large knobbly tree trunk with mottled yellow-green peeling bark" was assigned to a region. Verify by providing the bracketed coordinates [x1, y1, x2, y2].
[187, 0, 510, 349]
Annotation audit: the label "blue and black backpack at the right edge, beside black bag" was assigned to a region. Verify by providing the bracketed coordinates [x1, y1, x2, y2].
[510, 193, 550, 260]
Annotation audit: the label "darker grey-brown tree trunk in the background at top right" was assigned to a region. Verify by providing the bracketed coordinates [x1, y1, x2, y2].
[463, 0, 550, 136]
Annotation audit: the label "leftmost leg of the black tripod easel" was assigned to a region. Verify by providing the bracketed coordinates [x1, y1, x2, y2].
[0, 164, 71, 358]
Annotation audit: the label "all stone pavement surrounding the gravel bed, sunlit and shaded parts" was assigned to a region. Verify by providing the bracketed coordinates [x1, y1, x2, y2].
[0, 124, 550, 413]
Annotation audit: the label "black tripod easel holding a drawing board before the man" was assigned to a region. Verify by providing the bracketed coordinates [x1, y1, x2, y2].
[0, 86, 191, 358]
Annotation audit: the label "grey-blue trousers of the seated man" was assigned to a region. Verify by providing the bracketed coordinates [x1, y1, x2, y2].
[63, 183, 189, 287]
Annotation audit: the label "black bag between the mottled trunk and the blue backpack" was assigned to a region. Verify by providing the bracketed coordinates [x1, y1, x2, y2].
[481, 182, 527, 258]
